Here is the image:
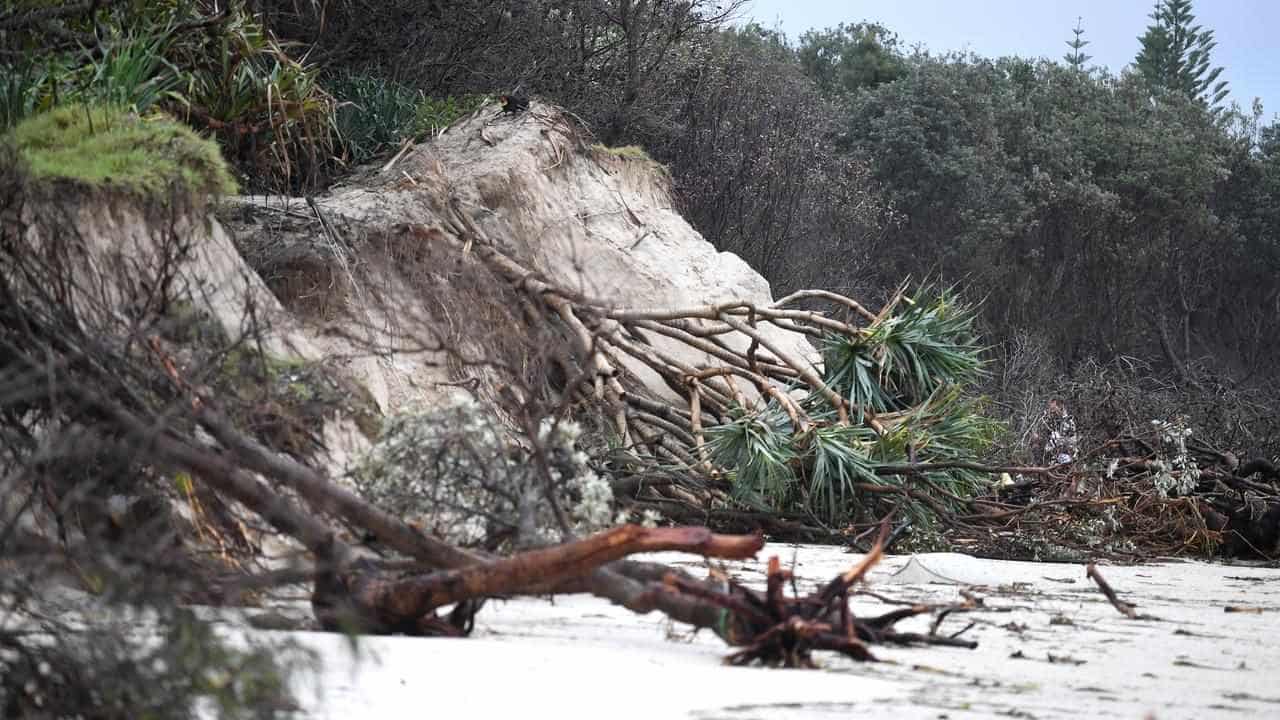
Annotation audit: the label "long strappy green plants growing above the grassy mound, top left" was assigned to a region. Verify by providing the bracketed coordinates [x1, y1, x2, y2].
[0, 0, 334, 190]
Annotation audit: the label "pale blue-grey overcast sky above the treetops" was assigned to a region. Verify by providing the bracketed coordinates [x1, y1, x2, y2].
[745, 0, 1280, 118]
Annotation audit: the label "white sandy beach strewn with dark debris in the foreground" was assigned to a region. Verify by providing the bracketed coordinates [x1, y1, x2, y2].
[254, 546, 1280, 719]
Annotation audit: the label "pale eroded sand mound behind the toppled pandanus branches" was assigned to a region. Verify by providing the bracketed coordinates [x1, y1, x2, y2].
[223, 102, 813, 422]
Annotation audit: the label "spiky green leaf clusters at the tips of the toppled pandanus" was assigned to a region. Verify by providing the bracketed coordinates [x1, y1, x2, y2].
[708, 290, 998, 524]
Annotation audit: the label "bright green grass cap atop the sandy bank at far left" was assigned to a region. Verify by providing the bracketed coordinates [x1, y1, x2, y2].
[5, 105, 236, 199]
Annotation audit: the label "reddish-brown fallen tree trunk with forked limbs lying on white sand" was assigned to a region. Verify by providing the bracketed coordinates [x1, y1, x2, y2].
[68, 387, 763, 634]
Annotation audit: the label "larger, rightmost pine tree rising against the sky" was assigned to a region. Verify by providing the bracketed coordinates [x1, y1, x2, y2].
[1135, 0, 1228, 111]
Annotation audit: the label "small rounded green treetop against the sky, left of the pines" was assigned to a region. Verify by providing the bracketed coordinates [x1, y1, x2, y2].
[799, 23, 906, 95]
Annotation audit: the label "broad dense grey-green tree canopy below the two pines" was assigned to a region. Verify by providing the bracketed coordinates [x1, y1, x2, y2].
[842, 55, 1259, 371]
